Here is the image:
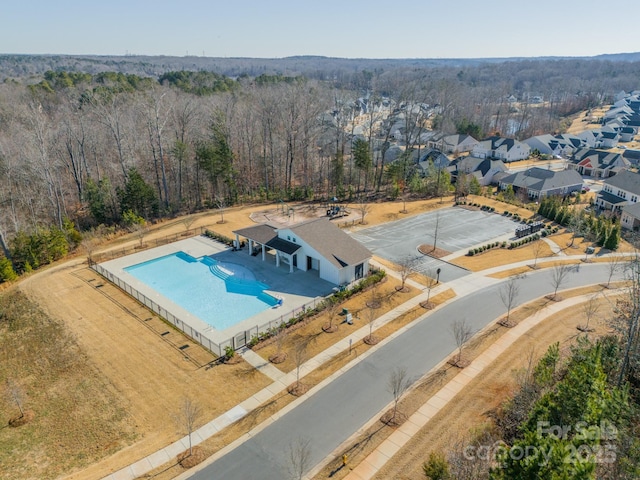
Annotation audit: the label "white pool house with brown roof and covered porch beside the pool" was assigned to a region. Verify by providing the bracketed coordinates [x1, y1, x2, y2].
[233, 217, 372, 285]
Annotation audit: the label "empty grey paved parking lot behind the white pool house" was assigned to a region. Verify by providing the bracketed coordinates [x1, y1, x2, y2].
[352, 207, 517, 282]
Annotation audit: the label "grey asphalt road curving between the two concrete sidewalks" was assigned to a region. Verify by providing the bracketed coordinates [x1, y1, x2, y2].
[190, 264, 622, 480]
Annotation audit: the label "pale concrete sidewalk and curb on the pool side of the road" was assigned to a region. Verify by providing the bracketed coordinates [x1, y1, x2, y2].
[104, 244, 632, 480]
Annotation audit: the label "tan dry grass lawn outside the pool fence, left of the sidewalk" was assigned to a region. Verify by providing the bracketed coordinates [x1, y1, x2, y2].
[16, 262, 270, 479]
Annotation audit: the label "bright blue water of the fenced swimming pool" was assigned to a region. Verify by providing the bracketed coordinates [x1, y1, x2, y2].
[124, 252, 278, 330]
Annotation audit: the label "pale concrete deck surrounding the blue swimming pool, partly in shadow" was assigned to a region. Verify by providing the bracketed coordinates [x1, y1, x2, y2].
[101, 236, 335, 344]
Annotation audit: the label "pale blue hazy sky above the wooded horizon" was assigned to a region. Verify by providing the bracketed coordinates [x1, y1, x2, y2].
[5, 0, 640, 58]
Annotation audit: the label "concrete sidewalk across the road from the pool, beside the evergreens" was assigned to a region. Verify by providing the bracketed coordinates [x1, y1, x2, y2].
[342, 295, 624, 480]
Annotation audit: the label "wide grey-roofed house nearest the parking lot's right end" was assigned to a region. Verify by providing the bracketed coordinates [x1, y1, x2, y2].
[500, 167, 582, 199]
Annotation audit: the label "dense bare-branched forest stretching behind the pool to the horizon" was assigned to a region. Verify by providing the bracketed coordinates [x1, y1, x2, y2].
[0, 56, 640, 276]
